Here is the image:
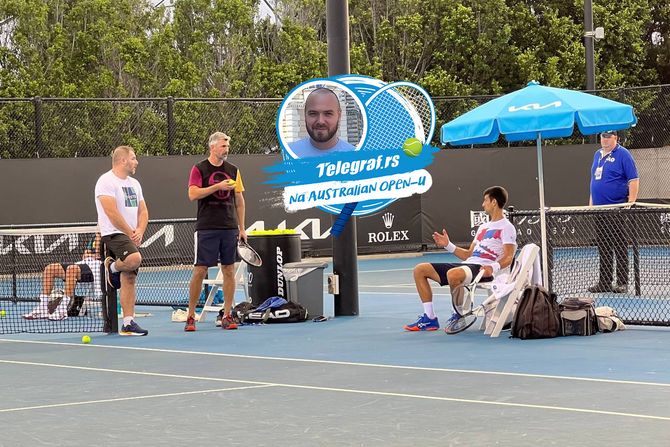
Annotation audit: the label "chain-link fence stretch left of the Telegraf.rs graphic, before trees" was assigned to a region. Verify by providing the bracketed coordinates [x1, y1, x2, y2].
[0, 98, 281, 158]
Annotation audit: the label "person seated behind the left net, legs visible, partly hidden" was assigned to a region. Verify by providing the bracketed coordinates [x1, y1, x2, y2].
[23, 234, 102, 320]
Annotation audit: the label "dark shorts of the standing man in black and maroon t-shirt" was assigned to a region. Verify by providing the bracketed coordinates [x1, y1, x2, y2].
[194, 229, 240, 267]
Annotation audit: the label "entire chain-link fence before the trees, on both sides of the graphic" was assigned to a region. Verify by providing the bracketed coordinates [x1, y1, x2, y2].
[0, 85, 670, 159]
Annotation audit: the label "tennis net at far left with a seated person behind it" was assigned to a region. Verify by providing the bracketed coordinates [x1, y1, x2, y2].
[0, 225, 104, 334]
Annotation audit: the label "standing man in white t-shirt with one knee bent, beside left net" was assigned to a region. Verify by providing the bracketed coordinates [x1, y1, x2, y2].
[95, 146, 149, 335]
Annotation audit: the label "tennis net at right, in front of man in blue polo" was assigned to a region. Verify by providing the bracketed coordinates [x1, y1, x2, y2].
[509, 204, 670, 326]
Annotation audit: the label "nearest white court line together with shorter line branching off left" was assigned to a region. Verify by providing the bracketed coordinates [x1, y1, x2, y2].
[0, 360, 670, 421]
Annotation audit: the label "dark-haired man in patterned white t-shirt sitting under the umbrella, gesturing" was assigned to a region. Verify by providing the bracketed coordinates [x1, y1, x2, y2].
[404, 186, 516, 332]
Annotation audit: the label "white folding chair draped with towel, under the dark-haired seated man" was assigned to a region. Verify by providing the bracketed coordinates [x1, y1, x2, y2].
[465, 244, 540, 337]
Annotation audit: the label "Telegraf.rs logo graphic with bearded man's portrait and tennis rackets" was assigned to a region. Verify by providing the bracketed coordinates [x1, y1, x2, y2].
[267, 75, 439, 236]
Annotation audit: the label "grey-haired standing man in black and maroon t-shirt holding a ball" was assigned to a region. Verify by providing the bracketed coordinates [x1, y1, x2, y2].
[184, 132, 247, 332]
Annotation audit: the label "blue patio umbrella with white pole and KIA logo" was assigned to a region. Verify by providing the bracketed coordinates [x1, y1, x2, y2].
[440, 81, 637, 285]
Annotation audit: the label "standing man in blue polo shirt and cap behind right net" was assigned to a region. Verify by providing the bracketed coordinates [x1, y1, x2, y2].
[588, 130, 640, 293]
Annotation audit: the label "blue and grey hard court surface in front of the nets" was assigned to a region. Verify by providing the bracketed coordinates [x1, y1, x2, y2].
[0, 254, 670, 447]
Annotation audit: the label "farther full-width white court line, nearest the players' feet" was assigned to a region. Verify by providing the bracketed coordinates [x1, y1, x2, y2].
[0, 338, 670, 388]
